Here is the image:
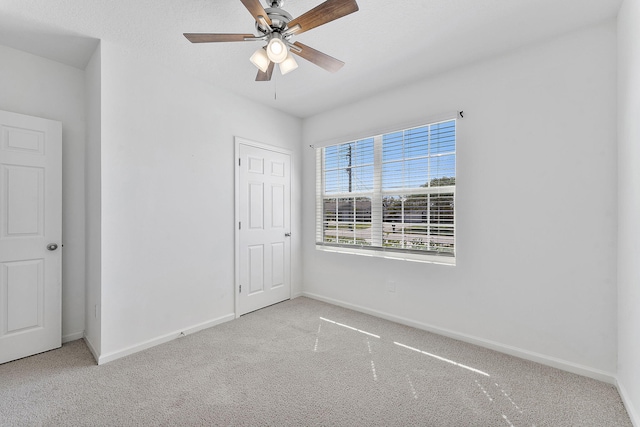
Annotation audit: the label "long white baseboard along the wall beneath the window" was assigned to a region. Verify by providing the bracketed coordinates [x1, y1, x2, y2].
[303, 292, 616, 386]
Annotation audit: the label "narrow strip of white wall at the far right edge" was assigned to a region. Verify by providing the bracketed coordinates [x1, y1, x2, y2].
[618, 0, 640, 426]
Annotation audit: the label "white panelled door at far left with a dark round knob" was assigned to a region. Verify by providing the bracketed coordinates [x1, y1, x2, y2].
[0, 111, 62, 363]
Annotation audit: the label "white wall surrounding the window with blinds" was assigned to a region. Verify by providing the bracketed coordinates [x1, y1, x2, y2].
[303, 22, 617, 381]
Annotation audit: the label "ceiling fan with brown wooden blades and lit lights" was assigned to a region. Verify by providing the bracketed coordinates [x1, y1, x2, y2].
[184, 0, 359, 81]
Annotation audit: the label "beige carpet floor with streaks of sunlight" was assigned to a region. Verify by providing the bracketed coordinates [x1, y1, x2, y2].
[0, 298, 631, 427]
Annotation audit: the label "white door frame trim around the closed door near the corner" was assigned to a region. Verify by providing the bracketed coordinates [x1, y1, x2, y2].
[233, 136, 293, 319]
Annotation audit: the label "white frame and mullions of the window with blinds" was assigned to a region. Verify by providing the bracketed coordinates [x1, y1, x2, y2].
[314, 113, 458, 265]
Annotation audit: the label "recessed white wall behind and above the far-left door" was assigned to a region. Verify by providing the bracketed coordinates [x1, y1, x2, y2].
[0, 45, 85, 341]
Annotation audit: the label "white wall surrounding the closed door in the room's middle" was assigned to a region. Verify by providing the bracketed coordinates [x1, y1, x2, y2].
[100, 41, 302, 362]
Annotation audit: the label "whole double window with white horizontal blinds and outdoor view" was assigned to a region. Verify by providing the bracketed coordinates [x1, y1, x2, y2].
[316, 119, 456, 264]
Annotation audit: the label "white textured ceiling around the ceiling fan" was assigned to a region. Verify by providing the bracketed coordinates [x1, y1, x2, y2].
[0, 0, 621, 117]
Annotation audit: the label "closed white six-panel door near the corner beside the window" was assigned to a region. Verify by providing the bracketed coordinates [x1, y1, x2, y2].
[236, 141, 291, 316]
